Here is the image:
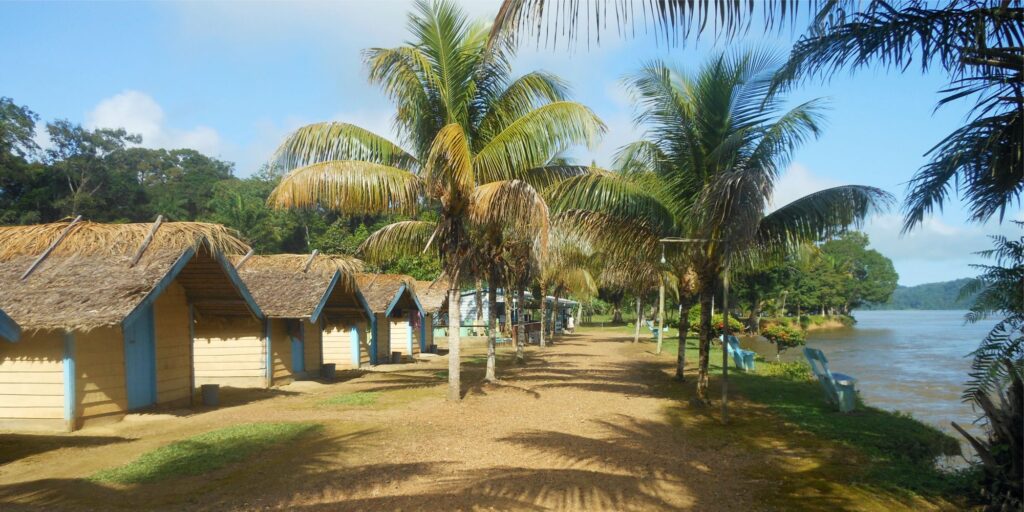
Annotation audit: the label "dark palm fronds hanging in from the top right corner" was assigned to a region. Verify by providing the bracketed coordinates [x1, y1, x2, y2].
[492, 0, 1024, 231]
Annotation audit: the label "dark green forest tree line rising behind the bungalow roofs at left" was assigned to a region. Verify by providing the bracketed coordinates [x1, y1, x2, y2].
[0, 97, 438, 280]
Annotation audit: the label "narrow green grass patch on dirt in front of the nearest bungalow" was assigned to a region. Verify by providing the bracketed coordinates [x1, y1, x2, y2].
[90, 423, 322, 483]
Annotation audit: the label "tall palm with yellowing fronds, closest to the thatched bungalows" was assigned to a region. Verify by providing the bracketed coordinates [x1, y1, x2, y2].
[269, 0, 604, 400]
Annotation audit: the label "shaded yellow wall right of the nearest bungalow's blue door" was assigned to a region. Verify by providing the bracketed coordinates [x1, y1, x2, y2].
[153, 283, 193, 407]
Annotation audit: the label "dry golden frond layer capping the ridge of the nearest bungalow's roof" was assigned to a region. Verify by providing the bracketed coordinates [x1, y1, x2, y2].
[0, 221, 249, 261]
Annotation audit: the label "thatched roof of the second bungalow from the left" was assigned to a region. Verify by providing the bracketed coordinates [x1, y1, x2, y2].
[231, 254, 362, 318]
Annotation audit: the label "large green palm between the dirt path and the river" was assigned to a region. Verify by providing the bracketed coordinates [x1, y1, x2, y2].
[545, 51, 891, 400]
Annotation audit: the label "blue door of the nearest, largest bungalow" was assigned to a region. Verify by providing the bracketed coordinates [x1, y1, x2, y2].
[124, 304, 157, 411]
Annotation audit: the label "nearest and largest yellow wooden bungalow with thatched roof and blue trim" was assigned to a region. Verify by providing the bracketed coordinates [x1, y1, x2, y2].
[0, 219, 263, 430]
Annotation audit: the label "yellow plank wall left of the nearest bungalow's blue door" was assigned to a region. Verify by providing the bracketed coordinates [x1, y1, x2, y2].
[75, 327, 128, 420]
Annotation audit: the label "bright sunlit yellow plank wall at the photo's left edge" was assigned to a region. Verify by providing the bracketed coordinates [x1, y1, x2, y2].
[0, 331, 66, 430]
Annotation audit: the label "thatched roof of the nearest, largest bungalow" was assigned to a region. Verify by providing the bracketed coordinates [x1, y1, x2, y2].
[0, 222, 260, 331]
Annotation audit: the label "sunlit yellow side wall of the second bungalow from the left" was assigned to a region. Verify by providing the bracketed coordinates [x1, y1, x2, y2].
[193, 317, 268, 387]
